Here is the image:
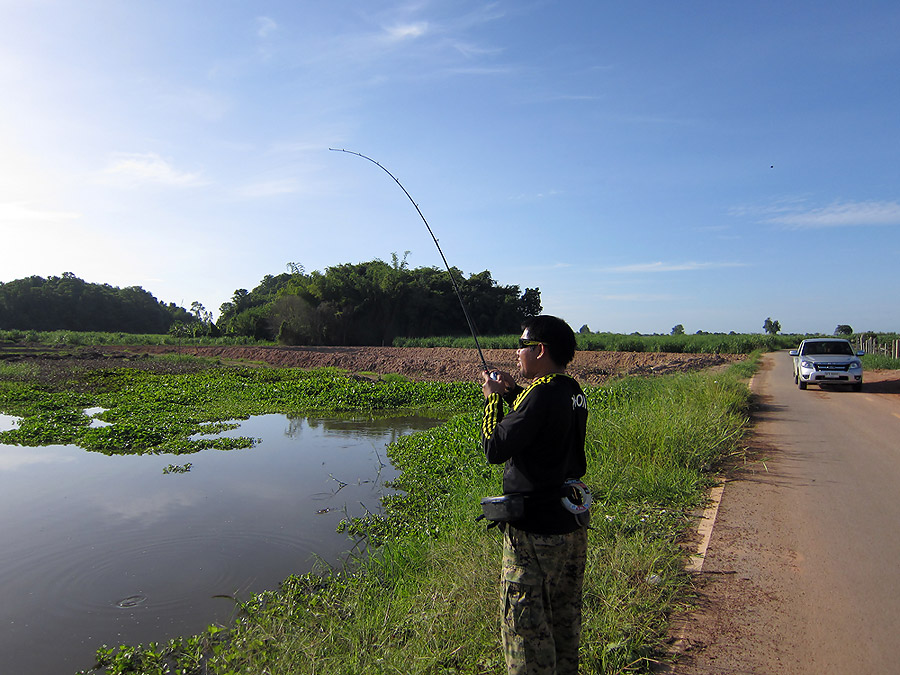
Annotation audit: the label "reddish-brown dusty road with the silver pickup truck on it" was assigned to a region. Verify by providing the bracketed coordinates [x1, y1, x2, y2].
[668, 352, 900, 675]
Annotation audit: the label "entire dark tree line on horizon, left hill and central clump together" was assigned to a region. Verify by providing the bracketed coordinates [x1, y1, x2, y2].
[0, 260, 541, 345]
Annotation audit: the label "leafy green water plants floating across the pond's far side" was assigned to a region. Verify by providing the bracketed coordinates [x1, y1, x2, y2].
[0, 367, 480, 454]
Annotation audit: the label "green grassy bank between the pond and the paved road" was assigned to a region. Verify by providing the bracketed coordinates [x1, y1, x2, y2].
[197, 364, 749, 674]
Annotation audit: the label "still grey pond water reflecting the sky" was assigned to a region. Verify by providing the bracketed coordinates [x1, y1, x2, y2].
[0, 415, 440, 675]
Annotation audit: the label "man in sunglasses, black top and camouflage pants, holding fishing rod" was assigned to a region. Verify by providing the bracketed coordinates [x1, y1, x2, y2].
[482, 315, 589, 675]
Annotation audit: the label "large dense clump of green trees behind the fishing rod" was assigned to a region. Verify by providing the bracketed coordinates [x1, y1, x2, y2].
[217, 253, 541, 345]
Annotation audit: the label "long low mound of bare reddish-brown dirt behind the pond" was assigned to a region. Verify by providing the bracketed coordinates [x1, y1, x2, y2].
[95, 345, 744, 384]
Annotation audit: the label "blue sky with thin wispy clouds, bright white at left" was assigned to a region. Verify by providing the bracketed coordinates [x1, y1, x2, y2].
[0, 0, 900, 333]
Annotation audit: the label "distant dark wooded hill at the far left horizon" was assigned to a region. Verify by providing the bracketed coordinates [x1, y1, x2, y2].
[0, 272, 196, 333]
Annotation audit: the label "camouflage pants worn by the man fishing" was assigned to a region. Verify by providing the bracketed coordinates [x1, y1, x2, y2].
[500, 526, 587, 675]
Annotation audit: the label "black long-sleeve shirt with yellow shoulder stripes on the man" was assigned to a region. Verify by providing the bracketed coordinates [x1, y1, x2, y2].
[481, 373, 588, 534]
